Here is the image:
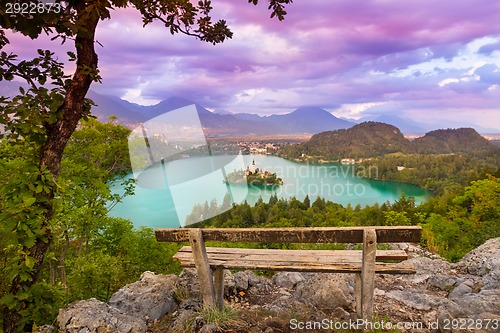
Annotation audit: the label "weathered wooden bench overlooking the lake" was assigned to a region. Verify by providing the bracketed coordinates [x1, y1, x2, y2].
[156, 226, 422, 320]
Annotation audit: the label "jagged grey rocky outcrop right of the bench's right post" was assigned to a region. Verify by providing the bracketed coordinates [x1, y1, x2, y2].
[375, 238, 500, 332]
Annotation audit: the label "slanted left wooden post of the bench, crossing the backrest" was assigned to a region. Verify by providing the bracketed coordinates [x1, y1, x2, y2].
[189, 229, 216, 306]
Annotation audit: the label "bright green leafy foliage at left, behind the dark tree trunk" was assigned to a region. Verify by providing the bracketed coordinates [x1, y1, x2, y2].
[0, 119, 179, 324]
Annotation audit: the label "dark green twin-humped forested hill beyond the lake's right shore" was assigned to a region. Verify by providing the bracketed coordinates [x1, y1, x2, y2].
[281, 121, 500, 160]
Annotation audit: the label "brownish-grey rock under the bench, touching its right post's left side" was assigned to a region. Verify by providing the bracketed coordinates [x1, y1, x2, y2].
[293, 273, 354, 309]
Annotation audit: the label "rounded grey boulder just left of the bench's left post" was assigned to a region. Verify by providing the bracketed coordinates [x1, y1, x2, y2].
[108, 272, 177, 322]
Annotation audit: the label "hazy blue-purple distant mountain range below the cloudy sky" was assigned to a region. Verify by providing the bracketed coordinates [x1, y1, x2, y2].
[0, 81, 498, 137]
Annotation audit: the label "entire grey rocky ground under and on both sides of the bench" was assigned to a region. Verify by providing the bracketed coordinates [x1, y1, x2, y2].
[54, 238, 500, 333]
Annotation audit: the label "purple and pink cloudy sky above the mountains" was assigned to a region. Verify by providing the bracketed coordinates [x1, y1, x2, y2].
[2, 0, 500, 132]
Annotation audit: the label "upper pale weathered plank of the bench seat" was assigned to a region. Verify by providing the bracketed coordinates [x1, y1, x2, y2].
[174, 246, 408, 261]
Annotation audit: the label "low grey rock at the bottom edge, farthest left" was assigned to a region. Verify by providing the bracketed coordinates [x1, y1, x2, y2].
[57, 298, 147, 333]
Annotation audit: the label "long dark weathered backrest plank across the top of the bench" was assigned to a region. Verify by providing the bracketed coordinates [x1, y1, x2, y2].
[156, 226, 422, 243]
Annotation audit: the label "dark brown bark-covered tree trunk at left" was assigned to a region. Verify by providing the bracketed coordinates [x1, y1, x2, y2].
[3, 1, 99, 333]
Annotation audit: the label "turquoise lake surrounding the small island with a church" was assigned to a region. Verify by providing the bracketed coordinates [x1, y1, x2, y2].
[110, 155, 429, 228]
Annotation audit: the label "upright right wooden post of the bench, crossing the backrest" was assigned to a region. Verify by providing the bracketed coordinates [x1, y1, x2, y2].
[361, 229, 377, 321]
